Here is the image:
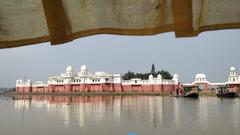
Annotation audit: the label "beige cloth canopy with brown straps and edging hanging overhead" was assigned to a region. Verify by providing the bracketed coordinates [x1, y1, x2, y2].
[0, 0, 240, 48]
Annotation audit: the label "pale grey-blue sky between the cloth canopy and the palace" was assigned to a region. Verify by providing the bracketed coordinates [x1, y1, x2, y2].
[0, 30, 240, 87]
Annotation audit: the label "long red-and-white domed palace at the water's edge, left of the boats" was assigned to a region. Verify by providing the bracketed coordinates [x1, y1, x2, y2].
[16, 65, 181, 93]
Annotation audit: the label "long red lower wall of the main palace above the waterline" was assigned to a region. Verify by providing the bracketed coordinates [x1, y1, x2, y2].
[16, 83, 182, 93]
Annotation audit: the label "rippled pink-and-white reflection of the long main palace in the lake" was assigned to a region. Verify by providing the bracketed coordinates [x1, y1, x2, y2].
[13, 96, 179, 128]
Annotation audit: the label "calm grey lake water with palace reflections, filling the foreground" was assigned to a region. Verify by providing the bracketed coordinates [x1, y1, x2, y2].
[0, 96, 240, 135]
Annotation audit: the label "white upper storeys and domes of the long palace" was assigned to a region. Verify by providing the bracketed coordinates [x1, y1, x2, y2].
[16, 65, 179, 87]
